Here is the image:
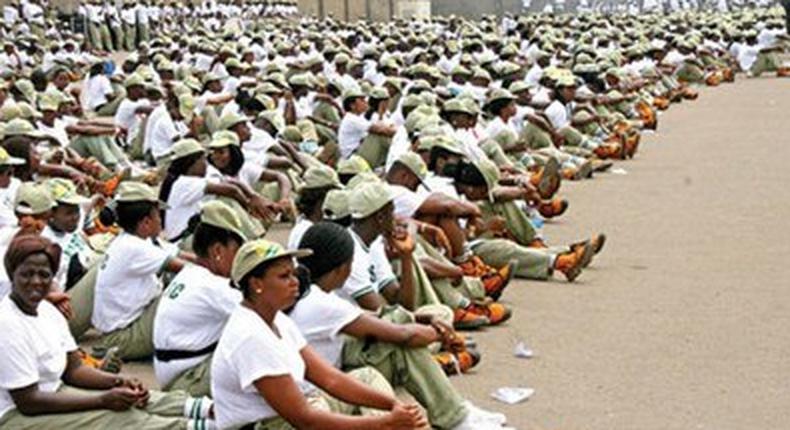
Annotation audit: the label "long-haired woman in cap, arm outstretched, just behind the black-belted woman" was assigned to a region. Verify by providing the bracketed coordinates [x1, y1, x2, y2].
[159, 139, 272, 241]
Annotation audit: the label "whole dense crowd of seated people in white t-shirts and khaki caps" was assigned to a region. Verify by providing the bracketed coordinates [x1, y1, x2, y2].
[0, 0, 790, 430]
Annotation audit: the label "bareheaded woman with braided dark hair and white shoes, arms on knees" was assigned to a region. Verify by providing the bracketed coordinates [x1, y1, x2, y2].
[289, 222, 505, 430]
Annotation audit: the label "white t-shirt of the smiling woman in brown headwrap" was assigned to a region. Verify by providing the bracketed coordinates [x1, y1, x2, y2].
[0, 296, 77, 417]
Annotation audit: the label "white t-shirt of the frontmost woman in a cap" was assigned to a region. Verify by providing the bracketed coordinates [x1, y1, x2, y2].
[211, 306, 307, 429]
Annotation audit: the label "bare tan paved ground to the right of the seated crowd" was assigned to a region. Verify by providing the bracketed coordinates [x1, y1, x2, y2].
[119, 75, 790, 430]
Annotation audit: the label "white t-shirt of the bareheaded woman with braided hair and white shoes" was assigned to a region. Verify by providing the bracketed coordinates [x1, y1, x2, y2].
[289, 285, 362, 368]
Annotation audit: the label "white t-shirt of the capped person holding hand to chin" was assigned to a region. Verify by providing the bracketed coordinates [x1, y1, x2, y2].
[337, 229, 397, 305]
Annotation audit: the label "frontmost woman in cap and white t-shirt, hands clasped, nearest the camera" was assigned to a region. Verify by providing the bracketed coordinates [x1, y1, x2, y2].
[211, 240, 427, 429]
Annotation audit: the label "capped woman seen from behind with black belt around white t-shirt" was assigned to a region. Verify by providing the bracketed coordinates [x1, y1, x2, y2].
[154, 201, 245, 396]
